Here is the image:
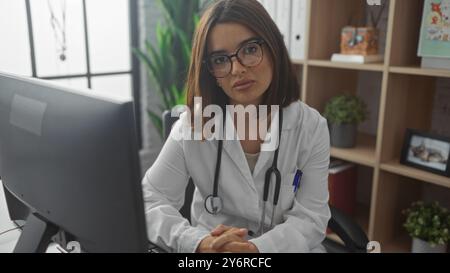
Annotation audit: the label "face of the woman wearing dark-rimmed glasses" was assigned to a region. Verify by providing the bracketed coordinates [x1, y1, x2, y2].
[208, 23, 273, 106]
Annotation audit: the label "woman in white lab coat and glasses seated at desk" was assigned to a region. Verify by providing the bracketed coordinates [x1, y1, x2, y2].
[143, 0, 330, 253]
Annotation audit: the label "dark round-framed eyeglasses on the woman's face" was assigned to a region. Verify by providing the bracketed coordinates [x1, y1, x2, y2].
[204, 39, 265, 78]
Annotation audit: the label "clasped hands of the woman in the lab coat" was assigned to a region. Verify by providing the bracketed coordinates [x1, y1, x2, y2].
[197, 225, 259, 253]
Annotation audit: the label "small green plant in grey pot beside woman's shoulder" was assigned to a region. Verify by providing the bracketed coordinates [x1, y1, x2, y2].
[323, 94, 369, 148]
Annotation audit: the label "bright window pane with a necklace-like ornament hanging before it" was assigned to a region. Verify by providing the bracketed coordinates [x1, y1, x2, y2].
[30, 0, 87, 78]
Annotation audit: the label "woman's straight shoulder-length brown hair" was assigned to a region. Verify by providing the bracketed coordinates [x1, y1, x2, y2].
[186, 0, 300, 121]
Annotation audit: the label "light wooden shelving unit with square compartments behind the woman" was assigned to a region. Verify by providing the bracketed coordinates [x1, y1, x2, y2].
[294, 0, 450, 252]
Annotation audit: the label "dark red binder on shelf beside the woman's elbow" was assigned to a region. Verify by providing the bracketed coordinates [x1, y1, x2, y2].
[328, 161, 357, 216]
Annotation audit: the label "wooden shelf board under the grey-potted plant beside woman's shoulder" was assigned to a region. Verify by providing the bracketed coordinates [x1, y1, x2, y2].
[331, 133, 376, 167]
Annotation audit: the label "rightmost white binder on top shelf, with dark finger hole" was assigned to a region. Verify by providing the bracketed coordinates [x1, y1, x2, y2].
[290, 0, 307, 60]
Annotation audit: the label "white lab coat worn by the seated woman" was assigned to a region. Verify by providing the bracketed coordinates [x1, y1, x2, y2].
[143, 101, 330, 253]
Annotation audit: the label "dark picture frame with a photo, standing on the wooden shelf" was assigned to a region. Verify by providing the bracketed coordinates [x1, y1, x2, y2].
[400, 129, 450, 177]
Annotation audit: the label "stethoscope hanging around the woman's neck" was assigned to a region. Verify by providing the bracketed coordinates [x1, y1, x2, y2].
[205, 109, 283, 235]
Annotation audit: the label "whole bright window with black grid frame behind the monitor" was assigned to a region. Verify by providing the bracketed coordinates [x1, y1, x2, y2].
[0, 0, 142, 146]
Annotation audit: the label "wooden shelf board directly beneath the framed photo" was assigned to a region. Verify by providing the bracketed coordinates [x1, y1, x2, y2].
[380, 160, 450, 188]
